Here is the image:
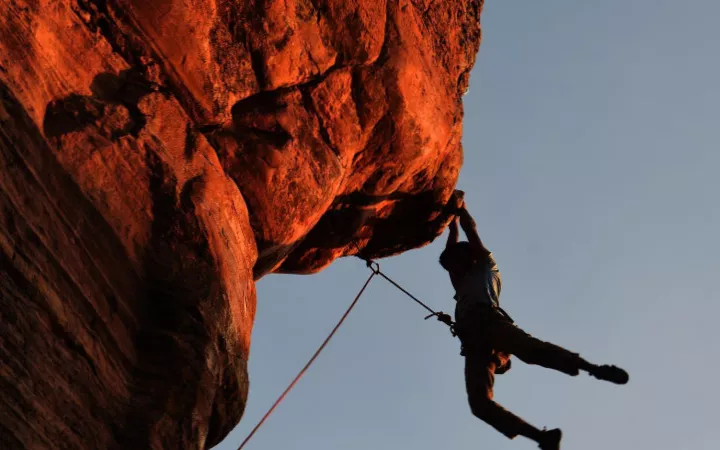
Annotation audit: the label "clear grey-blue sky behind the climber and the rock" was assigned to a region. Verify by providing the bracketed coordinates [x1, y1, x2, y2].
[217, 0, 720, 450]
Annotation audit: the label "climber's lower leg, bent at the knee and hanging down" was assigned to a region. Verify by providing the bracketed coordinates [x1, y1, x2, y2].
[465, 352, 561, 450]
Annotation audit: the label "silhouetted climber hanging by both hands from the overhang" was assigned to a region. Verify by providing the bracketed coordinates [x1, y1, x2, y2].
[440, 191, 629, 450]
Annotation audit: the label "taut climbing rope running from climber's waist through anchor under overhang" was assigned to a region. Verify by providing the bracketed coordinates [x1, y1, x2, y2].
[238, 253, 456, 450]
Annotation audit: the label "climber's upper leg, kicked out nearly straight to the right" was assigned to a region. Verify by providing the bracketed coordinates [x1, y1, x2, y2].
[485, 318, 629, 384]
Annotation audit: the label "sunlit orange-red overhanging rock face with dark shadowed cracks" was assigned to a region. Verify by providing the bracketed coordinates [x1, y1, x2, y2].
[0, 0, 482, 449]
